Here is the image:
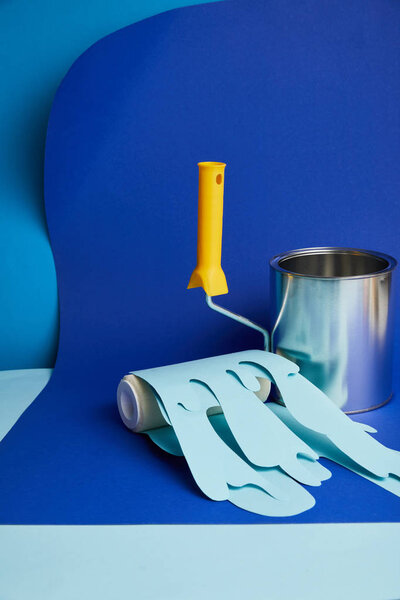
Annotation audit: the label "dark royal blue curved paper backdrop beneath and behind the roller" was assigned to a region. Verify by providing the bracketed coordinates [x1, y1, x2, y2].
[0, 0, 400, 523]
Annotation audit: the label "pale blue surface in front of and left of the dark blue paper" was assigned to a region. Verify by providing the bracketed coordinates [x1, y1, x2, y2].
[0, 369, 400, 600]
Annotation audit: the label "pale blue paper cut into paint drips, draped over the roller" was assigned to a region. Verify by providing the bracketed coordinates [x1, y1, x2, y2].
[119, 350, 400, 517]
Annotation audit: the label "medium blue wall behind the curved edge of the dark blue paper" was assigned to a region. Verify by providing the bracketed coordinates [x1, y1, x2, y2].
[0, 0, 219, 370]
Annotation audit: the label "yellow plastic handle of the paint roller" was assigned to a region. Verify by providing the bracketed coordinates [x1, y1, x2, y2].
[188, 162, 228, 296]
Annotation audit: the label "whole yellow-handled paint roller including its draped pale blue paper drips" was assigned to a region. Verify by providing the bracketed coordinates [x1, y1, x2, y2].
[117, 163, 400, 516]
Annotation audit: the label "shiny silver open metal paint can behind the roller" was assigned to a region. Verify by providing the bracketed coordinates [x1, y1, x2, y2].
[270, 247, 397, 413]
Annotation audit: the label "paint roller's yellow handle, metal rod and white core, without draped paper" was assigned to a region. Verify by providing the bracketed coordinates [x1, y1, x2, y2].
[117, 162, 271, 433]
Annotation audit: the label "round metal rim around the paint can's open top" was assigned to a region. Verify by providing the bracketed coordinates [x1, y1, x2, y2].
[269, 246, 397, 280]
